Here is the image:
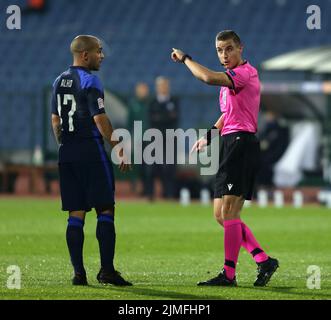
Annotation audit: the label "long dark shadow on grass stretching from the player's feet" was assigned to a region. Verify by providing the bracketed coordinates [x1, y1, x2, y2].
[89, 285, 224, 300]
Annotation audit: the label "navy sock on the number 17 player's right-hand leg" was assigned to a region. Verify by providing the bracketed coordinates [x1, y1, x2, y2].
[96, 213, 116, 273]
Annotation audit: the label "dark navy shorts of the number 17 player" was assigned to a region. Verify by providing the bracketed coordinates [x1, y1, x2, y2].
[59, 161, 115, 212]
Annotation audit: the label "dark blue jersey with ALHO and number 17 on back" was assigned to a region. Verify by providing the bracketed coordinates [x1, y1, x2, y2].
[52, 66, 108, 163]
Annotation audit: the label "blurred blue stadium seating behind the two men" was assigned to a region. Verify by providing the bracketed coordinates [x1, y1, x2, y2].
[0, 0, 331, 149]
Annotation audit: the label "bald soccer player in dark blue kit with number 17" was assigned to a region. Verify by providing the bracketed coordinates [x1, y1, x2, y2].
[52, 35, 132, 286]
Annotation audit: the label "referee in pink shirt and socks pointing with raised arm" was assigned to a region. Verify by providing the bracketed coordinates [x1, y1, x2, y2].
[171, 30, 278, 286]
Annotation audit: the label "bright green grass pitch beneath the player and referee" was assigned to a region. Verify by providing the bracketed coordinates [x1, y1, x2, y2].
[0, 198, 331, 300]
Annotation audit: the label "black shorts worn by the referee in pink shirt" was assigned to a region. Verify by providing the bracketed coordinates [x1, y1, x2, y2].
[214, 132, 260, 200]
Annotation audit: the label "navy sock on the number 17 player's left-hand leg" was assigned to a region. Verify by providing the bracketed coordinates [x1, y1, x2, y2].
[66, 217, 86, 275]
